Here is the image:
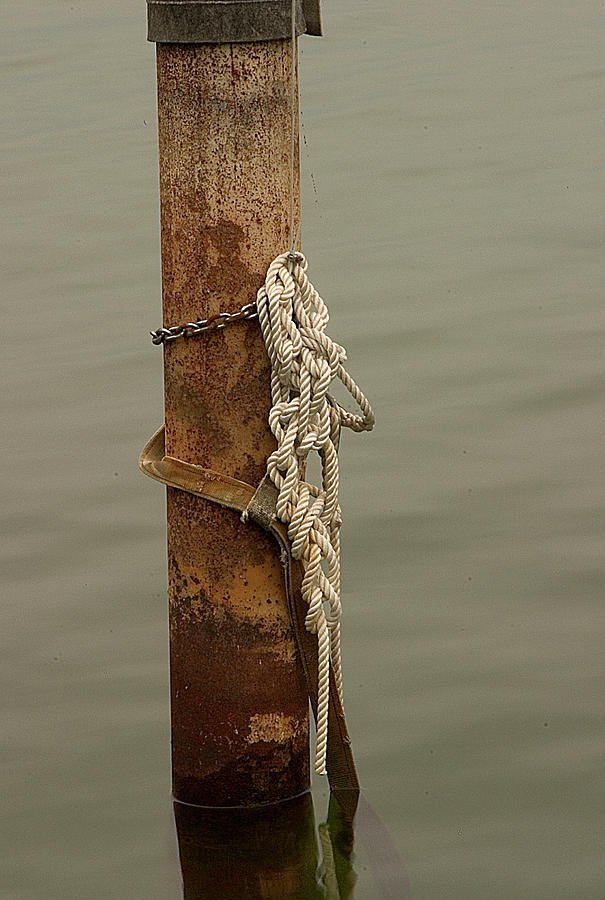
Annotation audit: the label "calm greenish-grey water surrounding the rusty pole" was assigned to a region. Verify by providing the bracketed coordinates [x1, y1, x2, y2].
[0, 0, 605, 900]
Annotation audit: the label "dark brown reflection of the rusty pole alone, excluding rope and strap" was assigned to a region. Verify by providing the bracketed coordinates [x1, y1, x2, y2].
[174, 794, 318, 900]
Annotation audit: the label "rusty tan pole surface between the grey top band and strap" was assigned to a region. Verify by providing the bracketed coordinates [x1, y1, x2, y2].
[157, 41, 298, 483]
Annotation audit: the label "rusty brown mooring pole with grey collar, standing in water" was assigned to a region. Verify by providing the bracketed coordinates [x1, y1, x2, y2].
[148, 0, 318, 806]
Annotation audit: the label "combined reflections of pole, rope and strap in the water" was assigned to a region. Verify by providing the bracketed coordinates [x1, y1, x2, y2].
[174, 793, 411, 900]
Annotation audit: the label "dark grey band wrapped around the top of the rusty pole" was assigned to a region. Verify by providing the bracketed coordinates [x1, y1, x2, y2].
[147, 0, 321, 44]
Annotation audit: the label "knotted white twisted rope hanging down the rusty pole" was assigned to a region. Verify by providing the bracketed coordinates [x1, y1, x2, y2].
[256, 252, 374, 775]
